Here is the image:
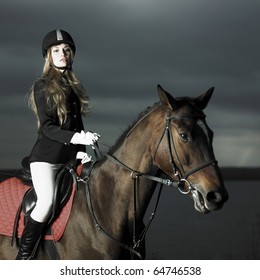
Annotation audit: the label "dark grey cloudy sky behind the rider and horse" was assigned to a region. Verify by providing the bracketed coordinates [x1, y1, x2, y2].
[0, 0, 260, 168]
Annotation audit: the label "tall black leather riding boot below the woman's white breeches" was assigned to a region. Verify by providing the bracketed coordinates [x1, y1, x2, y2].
[16, 216, 45, 260]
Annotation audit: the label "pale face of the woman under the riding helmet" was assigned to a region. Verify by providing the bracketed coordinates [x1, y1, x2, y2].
[51, 43, 71, 68]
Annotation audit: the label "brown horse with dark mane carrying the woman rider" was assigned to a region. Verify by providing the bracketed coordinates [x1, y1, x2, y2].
[0, 86, 228, 259]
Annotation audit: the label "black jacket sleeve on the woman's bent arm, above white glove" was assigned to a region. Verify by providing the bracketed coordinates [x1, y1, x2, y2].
[34, 80, 75, 145]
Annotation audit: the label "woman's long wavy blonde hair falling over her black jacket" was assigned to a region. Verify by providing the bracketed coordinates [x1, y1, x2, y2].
[28, 48, 89, 128]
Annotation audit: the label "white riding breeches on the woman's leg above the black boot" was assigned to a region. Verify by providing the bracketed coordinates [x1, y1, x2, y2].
[30, 162, 62, 223]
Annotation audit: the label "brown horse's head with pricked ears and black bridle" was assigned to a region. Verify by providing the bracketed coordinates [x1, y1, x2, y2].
[154, 86, 228, 213]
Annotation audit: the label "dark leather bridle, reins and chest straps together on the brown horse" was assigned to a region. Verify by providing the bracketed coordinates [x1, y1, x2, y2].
[70, 110, 217, 259]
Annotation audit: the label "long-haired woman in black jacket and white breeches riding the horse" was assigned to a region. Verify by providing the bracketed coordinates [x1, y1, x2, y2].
[16, 30, 99, 260]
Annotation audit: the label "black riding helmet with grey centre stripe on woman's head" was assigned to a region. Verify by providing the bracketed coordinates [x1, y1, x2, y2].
[42, 29, 76, 57]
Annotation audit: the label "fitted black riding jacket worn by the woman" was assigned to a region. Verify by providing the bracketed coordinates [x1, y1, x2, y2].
[29, 76, 85, 164]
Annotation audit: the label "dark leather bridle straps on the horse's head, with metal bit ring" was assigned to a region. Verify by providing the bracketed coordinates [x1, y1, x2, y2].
[162, 114, 217, 194]
